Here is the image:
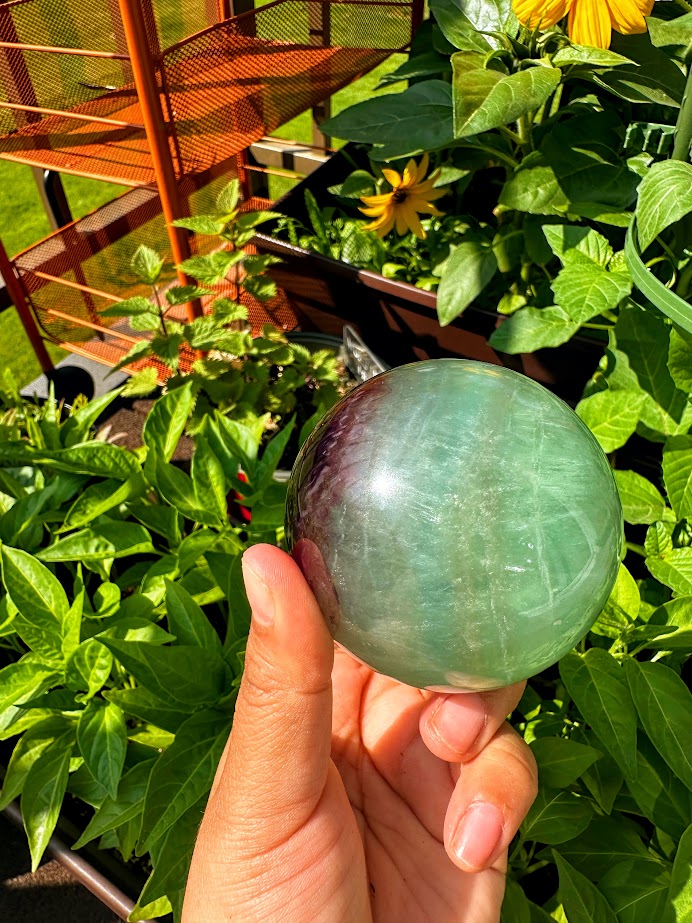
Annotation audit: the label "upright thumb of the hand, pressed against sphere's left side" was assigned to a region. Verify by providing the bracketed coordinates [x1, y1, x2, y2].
[219, 545, 334, 839]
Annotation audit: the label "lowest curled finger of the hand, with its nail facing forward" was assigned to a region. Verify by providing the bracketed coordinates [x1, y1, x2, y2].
[444, 724, 538, 872]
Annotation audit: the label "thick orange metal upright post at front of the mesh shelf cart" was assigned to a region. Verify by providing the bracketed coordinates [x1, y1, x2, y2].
[119, 0, 203, 321]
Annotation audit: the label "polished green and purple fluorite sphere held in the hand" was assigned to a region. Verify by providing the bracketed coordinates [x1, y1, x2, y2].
[287, 359, 623, 691]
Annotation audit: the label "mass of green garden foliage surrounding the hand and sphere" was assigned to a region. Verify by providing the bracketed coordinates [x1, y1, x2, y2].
[0, 0, 692, 923]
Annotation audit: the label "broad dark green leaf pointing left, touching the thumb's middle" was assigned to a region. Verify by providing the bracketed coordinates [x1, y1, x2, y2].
[102, 638, 230, 710]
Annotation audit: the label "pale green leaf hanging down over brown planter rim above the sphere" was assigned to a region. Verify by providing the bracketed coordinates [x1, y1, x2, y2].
[437, 240, 497, 327]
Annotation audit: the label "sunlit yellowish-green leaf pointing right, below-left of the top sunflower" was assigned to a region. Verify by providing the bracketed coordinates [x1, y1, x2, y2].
[452, 51, 561, 138]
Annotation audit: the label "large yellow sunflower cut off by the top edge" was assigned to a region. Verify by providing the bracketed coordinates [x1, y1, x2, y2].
[514, 0, 654, 48]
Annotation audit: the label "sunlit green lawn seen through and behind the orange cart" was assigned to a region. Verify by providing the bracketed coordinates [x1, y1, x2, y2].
[0, 55, 404, 386]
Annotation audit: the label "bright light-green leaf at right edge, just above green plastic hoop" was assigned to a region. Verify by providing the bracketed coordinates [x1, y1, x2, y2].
[637, 160, 692, 253]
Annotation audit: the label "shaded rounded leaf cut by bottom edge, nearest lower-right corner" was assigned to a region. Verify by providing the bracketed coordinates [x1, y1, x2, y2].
[598, 856, 670, 923]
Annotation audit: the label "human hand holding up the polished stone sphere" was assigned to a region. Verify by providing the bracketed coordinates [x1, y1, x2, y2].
[183, 545, 536, 923]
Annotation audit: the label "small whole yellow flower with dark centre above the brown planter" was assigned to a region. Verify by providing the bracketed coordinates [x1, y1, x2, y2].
[360, 154, 447, 240]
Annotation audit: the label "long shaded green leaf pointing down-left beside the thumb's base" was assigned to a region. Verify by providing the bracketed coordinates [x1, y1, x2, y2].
[138, 710, 230, 855]
